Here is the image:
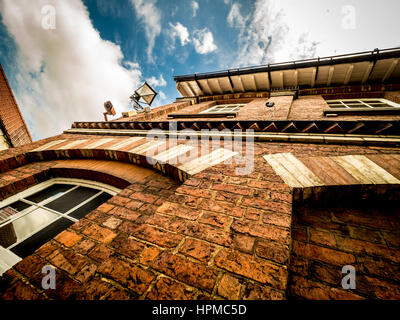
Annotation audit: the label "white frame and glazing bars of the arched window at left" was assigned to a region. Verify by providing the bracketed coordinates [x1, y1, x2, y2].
[0, 178, 121, 275]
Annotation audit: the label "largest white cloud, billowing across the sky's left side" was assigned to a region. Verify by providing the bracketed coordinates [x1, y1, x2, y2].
[0, 0, 141, 138]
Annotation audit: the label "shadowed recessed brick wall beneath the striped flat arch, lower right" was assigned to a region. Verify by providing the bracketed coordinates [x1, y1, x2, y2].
[289, 199, 400, 299]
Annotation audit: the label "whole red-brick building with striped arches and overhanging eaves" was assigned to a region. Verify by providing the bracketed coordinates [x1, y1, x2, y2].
[0, 49, 400, 300]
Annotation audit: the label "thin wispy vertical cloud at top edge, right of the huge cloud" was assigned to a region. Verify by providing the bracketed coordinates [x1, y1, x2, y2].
[131, 0, 161, 62]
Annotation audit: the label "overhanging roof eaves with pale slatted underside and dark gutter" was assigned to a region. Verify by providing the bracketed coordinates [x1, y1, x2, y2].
[174, 48, 400, 97]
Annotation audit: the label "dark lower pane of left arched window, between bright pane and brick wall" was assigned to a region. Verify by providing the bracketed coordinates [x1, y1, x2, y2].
[10, 218, 74, 258]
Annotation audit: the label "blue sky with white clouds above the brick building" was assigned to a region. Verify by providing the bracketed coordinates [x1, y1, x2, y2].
[0, 0, 400, 140]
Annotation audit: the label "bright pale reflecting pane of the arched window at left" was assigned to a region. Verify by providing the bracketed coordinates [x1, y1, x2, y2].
[0, 208, 59, 248]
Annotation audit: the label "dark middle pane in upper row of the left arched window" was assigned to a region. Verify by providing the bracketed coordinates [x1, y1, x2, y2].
[45, 187, 99, 213]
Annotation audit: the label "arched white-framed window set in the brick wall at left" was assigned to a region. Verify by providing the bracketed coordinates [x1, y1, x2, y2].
[0, 178, 119, 275]
